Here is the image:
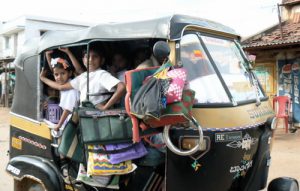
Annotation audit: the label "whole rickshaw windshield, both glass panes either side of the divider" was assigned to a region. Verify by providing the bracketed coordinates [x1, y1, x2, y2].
[180, 33, 263, 104]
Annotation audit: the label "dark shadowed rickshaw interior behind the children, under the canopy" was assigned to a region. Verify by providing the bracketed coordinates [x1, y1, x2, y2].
[41, 39, 162, 115]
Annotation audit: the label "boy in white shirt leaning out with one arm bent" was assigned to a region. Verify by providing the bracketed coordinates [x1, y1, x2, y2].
[40, 45, 125, 110]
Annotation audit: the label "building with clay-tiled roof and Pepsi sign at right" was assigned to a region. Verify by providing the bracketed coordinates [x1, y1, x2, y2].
[242, 0, 300, 127]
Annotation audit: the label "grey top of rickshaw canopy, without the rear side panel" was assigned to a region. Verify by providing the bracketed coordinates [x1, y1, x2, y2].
[38, 15, 238, 53]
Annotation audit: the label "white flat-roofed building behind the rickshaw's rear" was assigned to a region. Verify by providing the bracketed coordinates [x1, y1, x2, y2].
[0, 15, 91, 106]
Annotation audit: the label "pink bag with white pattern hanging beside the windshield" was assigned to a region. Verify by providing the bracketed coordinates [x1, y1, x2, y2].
[167, 68, 187, 104]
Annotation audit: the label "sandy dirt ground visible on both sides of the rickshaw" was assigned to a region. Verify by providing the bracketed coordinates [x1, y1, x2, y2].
[0, 107, 300, 191]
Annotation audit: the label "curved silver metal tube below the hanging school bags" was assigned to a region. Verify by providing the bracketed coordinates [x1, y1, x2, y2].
[163, 117, 203, 156]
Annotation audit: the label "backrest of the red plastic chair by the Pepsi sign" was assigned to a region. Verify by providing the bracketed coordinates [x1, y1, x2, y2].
[273, 96, 291, 117]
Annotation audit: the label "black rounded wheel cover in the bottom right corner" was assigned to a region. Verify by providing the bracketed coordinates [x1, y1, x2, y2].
[268, 177, 299, 191]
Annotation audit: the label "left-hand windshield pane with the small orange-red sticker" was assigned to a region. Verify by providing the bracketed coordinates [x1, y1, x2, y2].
[180, 34, 230, 104]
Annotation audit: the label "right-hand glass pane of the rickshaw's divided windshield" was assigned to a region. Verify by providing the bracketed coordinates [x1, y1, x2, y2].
[201, 35, 263, 102]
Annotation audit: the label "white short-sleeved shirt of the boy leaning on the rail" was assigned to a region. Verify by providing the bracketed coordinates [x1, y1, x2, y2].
[70, 69, 120, 105]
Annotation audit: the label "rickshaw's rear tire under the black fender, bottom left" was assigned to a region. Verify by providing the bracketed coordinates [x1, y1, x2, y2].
[14, 178, 46, 191]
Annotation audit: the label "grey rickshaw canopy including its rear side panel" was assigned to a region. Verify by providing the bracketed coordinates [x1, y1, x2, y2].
[12, 15, 238, 119]
